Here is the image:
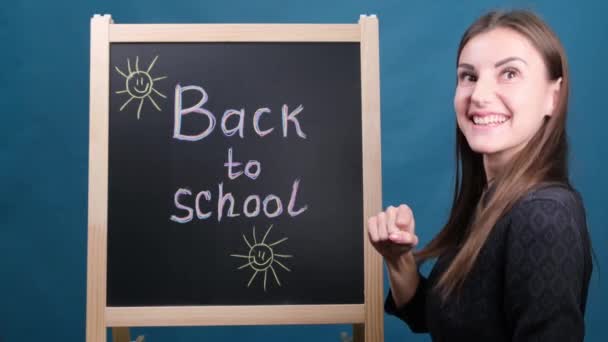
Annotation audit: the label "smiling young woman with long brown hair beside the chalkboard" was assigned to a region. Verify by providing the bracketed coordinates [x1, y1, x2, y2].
[368, 11, 592, 342]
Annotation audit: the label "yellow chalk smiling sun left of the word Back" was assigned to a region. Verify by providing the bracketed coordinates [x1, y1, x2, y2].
[114, 56, 167, 120]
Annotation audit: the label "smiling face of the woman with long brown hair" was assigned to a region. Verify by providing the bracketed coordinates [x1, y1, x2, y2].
[454, 28, 561, 160]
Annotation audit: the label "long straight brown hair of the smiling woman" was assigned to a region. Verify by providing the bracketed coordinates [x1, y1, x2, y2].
[414, 10, 569, 300]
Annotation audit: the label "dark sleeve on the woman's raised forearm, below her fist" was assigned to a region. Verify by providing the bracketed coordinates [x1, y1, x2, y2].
[384, 273, 429, 333]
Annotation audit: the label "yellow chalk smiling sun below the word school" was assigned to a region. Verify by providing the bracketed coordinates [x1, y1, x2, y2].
[230, 225, 293, 292]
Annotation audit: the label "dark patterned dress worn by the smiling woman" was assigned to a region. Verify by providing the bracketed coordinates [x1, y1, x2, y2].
[385, 185, 592, 342]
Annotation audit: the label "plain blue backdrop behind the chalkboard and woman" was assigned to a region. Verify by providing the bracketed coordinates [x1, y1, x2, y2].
[0, 0, 608, 342]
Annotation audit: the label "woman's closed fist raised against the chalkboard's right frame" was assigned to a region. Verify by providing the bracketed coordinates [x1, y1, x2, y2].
[367, 204, 418, 263]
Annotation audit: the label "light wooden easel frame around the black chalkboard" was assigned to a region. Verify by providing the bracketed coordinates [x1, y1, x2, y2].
[86, 15, 384, 342]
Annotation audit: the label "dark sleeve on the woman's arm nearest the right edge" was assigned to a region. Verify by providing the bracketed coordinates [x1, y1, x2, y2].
[504, 198, 586, 341]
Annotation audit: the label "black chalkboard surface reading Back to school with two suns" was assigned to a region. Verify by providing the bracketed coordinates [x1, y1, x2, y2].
[107, 43, 364, 306]
